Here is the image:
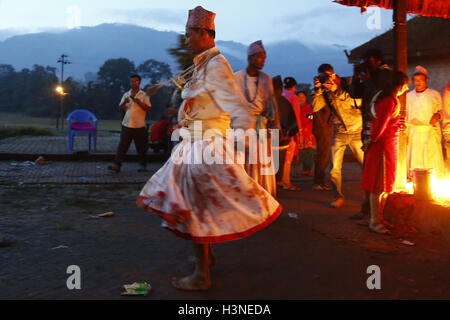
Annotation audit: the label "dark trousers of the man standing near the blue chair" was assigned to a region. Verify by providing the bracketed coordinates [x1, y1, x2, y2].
[114, 126, 148, 167]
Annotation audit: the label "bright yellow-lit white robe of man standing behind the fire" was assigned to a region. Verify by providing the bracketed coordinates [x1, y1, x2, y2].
[406, 88, 444, 177]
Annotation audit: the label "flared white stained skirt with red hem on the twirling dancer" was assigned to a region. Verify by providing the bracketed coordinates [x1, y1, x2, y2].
[138, 138, 282, 243]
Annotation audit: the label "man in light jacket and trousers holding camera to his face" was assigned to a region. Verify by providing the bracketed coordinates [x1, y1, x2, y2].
[313, 64, 364, 208]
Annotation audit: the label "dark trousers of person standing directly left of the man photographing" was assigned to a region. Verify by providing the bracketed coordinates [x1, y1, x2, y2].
[314, 128, 333, 184]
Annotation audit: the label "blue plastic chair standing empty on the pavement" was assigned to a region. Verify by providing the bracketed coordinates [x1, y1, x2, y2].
[67, 109, 98, 151]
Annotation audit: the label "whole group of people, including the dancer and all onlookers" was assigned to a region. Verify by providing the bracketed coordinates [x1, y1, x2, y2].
[109, 6, 450, 290]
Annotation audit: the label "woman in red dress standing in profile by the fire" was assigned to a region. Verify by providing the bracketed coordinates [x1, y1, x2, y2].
[361, 71, 408, 234]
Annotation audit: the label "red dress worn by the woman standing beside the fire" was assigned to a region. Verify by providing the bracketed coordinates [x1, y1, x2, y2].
[361, 97, 400, 193]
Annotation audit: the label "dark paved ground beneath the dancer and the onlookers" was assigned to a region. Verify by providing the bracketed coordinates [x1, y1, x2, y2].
[0, 161, 450, 300]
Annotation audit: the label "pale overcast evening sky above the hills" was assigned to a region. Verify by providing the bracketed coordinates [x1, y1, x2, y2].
[0, 0, 398, 48]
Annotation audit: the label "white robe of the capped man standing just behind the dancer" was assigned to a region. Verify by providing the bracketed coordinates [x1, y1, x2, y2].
[235, 69, 277, 196]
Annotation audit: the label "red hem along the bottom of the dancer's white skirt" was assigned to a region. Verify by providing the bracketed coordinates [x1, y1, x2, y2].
[138, 196, 283, 243]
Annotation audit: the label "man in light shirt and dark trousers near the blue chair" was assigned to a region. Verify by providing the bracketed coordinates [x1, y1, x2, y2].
[108, 74, 151, 172]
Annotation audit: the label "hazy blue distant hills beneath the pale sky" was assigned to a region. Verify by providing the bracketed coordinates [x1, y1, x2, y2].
[0, 24, 351, 83]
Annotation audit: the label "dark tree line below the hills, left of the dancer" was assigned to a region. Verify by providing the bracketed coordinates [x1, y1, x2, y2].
[0, 58, 173, 120]
